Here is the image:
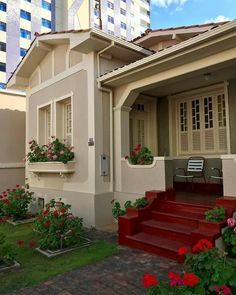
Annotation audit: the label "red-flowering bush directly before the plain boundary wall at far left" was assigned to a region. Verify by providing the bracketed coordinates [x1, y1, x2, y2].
[1, 184, 34, 221]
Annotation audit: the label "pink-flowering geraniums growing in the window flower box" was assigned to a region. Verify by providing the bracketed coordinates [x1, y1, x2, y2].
[26, 136, 74, 164]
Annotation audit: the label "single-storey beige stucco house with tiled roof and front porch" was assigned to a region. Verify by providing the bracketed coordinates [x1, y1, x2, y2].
[8, 21, 236, 227]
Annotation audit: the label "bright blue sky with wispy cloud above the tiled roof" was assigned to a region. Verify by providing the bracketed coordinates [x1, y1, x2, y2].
[151, 0, 236, 29]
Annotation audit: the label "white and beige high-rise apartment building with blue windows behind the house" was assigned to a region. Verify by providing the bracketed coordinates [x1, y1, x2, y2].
[0, 0, 150, 88]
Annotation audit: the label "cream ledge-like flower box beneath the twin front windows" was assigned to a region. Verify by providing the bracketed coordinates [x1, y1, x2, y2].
[28, 161, 75, 176]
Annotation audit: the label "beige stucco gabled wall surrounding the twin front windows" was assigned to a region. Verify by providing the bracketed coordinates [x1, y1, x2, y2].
[27, 46, 113, 227]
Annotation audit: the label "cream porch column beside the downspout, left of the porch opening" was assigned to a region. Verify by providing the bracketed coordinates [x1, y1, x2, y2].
[114, 106, 131, 191]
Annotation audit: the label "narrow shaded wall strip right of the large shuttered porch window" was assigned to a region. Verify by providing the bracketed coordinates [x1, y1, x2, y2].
[228, 80, 236, 154]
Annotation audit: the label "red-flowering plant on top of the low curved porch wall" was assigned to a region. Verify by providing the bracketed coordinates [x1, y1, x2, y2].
[125, 144, 153, 165]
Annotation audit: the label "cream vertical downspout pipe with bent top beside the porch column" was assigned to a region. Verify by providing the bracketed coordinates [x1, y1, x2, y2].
[98, 82, 114, 192]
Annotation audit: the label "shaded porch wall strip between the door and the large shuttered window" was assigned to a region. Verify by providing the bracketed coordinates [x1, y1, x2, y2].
[157, 97, 170, 156]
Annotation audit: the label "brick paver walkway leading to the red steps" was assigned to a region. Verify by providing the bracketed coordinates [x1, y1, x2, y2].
[6, 231, 181, 295]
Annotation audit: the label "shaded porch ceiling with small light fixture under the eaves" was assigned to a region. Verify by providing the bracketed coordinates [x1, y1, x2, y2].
[139, 60, 236, 96]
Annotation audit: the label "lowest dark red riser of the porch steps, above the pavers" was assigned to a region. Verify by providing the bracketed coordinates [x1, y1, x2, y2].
[122, 239, 183, 262]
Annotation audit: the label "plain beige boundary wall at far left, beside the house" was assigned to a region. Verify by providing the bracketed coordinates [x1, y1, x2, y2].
[0, 91, 25, 193]
